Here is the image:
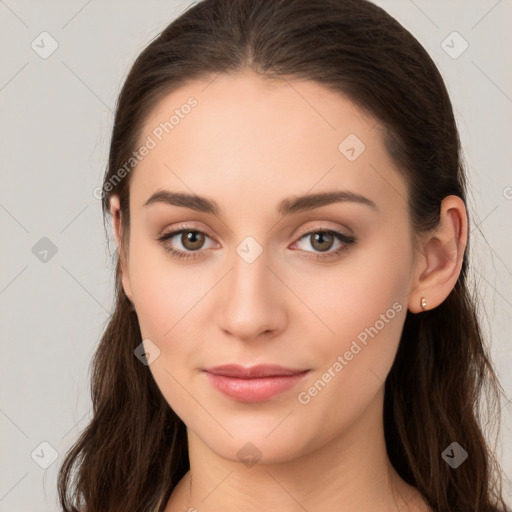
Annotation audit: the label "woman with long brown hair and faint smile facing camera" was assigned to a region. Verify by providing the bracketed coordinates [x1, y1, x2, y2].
[59, 0, 505, 512]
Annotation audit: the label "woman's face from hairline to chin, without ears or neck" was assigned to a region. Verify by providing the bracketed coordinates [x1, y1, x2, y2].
[115, 72, 415, 462]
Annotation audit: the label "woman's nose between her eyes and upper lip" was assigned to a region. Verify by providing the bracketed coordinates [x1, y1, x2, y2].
[217, 247, 287, 341]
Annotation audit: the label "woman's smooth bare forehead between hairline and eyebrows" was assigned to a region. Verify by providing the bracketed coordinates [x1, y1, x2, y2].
[130, 72, 406, 216]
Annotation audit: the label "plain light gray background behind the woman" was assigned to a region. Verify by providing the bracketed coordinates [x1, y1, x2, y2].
[0, 0, 512, 512]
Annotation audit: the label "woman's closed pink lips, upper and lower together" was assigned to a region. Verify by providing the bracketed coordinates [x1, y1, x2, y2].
[203, 364, 310, 403]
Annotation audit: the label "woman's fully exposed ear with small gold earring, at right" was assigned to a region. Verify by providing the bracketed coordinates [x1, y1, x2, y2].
[408, 195, 468, 313]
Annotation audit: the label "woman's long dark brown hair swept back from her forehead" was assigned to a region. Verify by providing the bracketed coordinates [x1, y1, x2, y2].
[58, 0, 507, 512]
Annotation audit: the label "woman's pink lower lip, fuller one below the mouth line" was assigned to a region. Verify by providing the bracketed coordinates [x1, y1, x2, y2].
[205, 370, 309, 402]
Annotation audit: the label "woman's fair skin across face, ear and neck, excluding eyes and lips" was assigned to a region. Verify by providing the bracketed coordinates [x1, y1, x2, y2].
[111, 71, 467, 512]
